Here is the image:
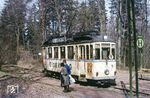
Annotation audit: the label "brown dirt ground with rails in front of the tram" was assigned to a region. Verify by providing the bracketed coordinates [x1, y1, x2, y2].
[0, 66, 150, 98]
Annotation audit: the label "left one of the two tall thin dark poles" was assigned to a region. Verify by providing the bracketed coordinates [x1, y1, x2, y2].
[127, 0, 133, 98]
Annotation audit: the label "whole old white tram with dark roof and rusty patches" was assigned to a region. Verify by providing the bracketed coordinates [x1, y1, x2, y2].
[42, 31, 116, 84]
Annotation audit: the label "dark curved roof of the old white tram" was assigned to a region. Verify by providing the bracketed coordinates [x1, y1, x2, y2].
[43, 31, 114, 47]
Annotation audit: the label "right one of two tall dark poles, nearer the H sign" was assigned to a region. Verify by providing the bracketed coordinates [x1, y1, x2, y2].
[131, 0, 139, 98]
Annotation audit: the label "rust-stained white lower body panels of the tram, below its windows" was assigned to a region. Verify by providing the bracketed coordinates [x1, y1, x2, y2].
[44, 53, 116, 82]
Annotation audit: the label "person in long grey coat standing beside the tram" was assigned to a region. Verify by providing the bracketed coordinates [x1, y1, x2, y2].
[60, 63, 70, 92]
